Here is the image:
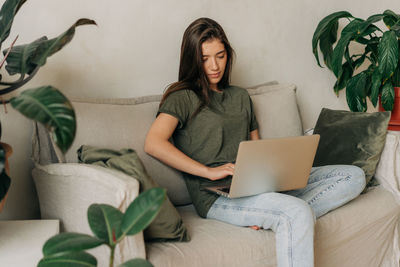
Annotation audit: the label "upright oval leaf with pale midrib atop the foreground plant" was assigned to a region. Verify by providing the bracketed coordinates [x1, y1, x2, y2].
[87, 204, 123, 245]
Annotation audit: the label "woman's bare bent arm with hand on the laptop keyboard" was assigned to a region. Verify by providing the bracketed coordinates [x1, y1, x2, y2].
[144, 113, 235, 180]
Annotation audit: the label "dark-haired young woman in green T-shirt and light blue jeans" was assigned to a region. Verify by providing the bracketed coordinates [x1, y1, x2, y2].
[145, 18, 365, 267]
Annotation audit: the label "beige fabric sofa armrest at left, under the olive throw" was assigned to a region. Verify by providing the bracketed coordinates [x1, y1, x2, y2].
[32, 163, 146, 266]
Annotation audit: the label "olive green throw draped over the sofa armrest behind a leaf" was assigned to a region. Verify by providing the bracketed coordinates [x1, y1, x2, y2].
[77, 145, 190, 244]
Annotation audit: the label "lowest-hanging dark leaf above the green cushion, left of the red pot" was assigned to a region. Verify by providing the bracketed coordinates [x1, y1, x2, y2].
[346, 71, 367, 112]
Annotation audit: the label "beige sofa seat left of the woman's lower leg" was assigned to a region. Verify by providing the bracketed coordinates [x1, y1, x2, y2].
[146, 205, 276, 267]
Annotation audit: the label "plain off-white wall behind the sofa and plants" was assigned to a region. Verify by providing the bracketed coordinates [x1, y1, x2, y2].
[0, 0, 400, 219]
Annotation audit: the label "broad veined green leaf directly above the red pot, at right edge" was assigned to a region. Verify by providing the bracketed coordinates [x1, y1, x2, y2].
[378, 31, 399, 79]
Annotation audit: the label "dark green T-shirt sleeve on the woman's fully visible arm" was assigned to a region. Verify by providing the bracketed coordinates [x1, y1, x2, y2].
[157, 90, 193, 129]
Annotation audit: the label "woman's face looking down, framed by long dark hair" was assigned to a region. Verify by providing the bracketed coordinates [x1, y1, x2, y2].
[201, 39, 227, 91]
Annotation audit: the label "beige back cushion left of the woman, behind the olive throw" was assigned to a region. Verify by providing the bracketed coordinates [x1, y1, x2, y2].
[66, 96, 191, 205]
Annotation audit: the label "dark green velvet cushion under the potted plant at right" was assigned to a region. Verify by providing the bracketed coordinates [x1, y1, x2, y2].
[313, 108, 390, 185]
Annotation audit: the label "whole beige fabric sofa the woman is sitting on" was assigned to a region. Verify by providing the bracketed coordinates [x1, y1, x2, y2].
[33, 82, 400, 267]
